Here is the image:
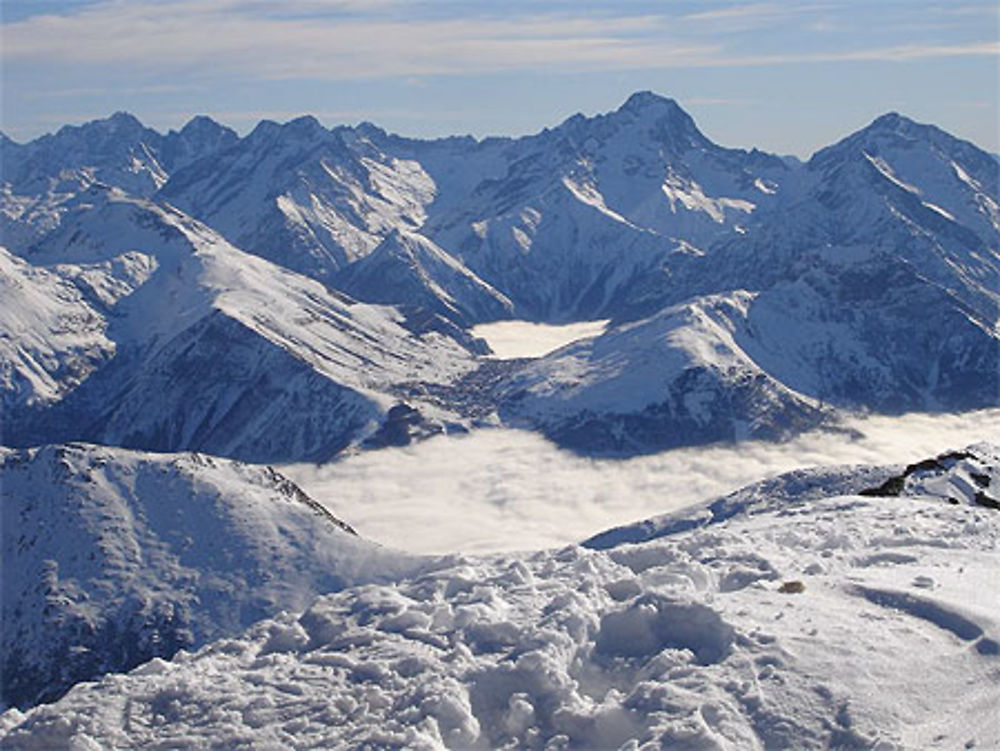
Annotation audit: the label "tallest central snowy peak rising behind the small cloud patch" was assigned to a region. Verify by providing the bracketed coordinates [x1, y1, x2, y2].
[414, 92, 789, 321]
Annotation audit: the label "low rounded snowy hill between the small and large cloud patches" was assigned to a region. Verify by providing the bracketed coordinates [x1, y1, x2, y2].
[499, 292, 823, 454]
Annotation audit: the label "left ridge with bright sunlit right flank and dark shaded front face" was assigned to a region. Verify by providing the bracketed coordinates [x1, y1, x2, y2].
[4, 188, 473, 461]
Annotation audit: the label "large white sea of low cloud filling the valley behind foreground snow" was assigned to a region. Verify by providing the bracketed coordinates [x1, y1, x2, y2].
[280, 409, 1000, 553]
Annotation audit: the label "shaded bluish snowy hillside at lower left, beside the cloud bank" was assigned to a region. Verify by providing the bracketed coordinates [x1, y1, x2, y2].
[0, 444, 416, 707]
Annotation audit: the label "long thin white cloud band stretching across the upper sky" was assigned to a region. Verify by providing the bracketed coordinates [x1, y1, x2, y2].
[3, 0, 1000, 80]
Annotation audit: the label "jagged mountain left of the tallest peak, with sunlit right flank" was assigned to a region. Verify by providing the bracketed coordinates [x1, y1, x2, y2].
[160, 117, 435, 281]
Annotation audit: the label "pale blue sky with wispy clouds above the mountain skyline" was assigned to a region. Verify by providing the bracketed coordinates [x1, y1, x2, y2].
[0, 0, 1000, 156]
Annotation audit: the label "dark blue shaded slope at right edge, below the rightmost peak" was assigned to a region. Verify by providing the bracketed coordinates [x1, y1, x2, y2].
[732, 258, 1000, 413]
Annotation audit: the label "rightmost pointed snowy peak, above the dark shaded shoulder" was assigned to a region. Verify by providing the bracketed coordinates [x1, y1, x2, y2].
[622, 108, 1000, 322]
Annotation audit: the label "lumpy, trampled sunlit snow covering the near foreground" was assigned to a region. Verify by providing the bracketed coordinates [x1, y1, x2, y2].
[0, 448, 1000, 750]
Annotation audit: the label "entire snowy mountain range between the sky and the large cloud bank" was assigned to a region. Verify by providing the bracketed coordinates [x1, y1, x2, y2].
[0, 92, 1000, 462]
